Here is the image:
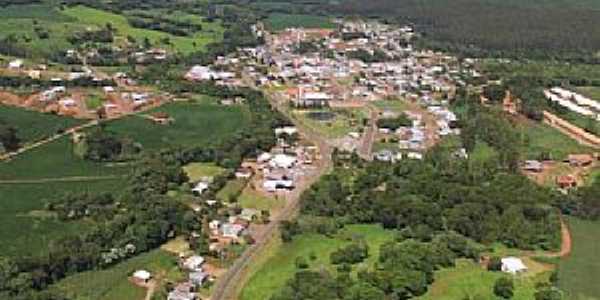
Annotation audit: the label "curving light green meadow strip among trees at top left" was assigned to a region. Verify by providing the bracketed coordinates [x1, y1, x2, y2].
[63, 6, 223, 53]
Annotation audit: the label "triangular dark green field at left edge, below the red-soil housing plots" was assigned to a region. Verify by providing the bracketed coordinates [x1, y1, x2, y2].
[0, 105, 83, 143]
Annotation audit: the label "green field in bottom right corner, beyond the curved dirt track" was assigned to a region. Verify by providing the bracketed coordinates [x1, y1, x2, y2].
[558, 218, 600, 300]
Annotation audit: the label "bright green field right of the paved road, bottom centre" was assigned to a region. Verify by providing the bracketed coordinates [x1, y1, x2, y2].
[240, 225, 394, 300]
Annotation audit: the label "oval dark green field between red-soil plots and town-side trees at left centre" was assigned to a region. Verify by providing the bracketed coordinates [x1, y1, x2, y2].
[106, 100, 249, 150]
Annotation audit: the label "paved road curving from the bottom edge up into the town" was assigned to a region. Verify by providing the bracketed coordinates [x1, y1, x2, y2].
[211, 90, 332, 300]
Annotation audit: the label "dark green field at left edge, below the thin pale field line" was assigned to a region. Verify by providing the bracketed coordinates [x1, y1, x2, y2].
[0, 180, 123, 255]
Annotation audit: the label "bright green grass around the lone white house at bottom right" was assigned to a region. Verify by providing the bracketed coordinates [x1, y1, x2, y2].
[418, 259, 547, 300]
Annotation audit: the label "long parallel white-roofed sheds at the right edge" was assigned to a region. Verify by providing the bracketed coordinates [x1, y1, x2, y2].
[544, 87, 600, 121]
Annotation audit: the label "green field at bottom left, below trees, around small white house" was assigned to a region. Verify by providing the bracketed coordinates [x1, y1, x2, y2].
[51, 250, 182, 300]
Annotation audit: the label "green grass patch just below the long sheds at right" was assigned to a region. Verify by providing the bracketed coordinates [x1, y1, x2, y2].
[517, 121, 593, 160]
